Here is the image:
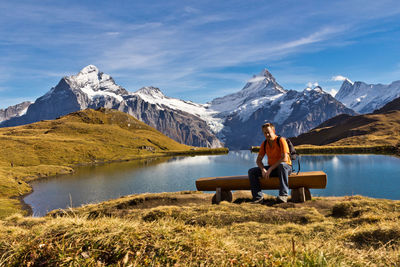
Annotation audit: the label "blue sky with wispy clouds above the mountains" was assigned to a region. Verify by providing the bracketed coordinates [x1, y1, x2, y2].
[0, 0, 400, 108]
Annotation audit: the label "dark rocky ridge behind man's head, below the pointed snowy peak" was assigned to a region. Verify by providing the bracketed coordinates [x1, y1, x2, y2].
[223, 86, 356, 149]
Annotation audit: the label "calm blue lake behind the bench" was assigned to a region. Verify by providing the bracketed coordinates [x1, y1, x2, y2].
[24, 150, 400, 216]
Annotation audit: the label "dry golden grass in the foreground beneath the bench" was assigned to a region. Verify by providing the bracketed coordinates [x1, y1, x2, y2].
[0, 191, 400, 266]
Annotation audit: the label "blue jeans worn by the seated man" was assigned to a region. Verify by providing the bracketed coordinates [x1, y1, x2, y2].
[249, 162, 292, 199]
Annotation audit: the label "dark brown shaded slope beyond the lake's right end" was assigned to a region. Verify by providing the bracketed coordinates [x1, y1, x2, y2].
[291, 110, 400, 146]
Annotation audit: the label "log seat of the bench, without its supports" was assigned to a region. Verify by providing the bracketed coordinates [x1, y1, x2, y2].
[196, 171, 327, 191]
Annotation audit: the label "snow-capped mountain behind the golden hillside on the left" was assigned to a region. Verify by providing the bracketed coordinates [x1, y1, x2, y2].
[0, 65, 222, 147]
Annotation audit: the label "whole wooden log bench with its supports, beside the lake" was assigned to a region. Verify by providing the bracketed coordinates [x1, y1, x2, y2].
[196, 171, 327, 204]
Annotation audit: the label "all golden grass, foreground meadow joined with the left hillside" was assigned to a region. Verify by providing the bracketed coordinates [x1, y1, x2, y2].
[0, 110, 400, 266]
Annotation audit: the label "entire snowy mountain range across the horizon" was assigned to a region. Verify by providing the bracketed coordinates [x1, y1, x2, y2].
[0, 65, 400, 149]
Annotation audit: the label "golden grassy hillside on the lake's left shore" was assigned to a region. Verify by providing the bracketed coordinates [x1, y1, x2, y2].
[0, 108, 226, 217]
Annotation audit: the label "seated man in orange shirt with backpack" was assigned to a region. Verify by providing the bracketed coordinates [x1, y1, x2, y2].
[249, 123, 292, 203]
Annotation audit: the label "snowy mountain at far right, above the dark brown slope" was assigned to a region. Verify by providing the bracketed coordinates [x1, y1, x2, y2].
[335, 80, 400, 114]
